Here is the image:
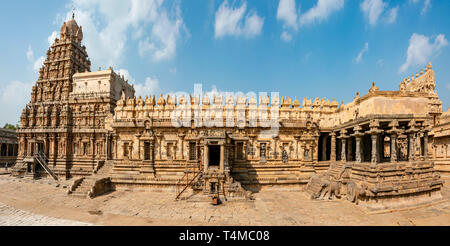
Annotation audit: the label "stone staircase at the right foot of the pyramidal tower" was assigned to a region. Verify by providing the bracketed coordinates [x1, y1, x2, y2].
[69, 161, 114, 198]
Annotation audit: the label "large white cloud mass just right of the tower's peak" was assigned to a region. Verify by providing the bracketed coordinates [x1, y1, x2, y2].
[60, 0, 189, 66]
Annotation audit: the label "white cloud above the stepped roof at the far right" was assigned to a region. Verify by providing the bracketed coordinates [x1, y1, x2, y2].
[399, 33, 448, 73]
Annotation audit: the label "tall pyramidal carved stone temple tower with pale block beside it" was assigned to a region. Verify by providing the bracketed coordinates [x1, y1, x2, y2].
[17, 16, 134, 179]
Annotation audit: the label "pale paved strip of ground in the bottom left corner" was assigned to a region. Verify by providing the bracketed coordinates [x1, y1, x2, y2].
[0, 203, 92, 226]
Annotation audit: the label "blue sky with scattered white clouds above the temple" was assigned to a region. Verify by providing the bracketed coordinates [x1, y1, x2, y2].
[0, 0, 450, 126]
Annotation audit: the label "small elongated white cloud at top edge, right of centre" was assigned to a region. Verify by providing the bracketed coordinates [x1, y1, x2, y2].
[300, 0, 344, 25]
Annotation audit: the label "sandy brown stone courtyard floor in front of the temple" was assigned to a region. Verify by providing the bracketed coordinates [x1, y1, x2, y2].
[0, 175, 450, 226]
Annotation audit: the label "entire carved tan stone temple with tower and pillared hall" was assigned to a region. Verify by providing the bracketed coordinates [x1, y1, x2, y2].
[15, 16, 450, 209]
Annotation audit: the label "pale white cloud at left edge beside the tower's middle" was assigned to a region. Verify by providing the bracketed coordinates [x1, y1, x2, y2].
[0, 81, 33, 126]
